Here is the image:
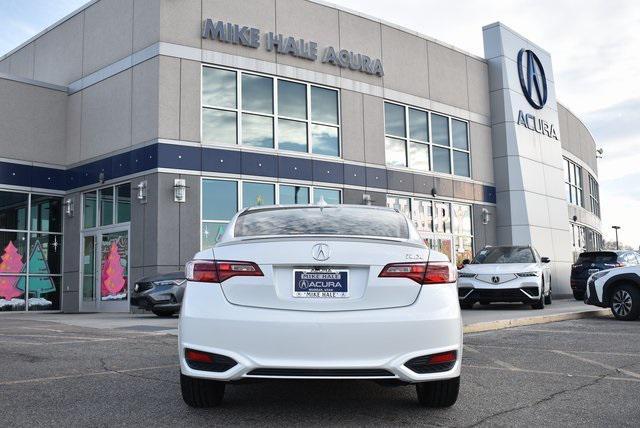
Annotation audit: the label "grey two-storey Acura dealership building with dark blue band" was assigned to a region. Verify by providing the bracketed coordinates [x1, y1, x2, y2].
[0, 0, 602, 312]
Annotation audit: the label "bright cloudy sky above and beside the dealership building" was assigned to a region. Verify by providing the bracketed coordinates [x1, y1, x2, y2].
[0, 0, 640, 248]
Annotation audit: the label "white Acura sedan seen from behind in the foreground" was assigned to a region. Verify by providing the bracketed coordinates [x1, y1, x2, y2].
[179, 205, 462, 407]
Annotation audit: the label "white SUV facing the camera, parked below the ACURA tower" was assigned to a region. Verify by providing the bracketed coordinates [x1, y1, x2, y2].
[458, 245, 552, 309]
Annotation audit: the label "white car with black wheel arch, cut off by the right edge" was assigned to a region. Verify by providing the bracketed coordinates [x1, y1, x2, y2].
[585, 265, 640, 321]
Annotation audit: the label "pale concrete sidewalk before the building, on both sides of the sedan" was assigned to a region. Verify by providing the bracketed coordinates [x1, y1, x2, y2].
[0, 300, 611, 335]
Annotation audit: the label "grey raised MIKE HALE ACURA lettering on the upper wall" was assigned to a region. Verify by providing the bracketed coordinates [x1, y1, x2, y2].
[202, 19, 384, 77]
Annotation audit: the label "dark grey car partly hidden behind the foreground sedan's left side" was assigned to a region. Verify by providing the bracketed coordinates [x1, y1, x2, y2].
[131, 272, 187, 317]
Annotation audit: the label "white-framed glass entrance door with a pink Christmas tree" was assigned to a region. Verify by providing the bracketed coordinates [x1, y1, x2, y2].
[80, 226, 129, 312]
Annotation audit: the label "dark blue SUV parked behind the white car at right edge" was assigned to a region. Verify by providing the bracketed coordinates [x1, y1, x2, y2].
[571, 250, 639, 300]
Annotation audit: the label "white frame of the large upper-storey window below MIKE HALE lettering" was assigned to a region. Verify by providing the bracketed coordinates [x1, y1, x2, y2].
[200, 63, 343, 159]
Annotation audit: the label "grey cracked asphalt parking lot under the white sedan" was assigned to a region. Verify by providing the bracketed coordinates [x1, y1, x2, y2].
[0, 317, 640, 427]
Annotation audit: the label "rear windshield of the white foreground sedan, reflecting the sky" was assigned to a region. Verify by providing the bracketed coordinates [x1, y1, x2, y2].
[234, 207, 409, 239]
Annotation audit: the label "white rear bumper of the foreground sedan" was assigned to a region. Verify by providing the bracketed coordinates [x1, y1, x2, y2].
[179, 283, 462, 383]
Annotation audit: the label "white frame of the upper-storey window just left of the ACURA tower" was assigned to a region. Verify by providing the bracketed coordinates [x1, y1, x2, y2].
[382, 99, 472, 179]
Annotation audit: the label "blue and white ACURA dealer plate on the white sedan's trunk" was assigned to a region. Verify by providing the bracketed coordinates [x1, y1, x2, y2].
[293, 270, 349, 298]
